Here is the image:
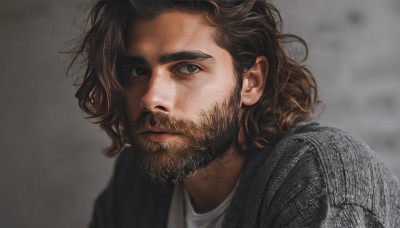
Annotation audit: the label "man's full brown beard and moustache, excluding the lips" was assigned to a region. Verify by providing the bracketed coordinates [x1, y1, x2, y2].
[128, 88, 240, 183]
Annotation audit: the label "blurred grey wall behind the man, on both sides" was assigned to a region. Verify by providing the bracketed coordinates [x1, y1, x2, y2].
[0, 0, 400, 228]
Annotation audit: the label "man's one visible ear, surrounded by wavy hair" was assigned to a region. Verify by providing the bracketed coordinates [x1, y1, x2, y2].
[241, 56, 269, 106]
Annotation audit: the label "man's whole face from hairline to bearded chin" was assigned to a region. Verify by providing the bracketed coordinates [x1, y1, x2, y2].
[123, 11, 240, 182]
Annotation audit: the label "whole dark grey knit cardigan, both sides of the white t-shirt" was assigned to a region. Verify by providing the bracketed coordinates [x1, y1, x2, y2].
[90, 123, 400, 228]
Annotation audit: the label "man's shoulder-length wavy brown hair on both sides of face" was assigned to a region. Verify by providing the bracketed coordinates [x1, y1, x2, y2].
[70, 0, 319, 156]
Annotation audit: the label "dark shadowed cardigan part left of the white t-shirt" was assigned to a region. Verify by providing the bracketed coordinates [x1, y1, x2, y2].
[90, 148, 173, 227]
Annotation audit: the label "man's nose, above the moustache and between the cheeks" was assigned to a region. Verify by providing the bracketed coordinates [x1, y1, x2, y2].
[141, 74, 174, 114]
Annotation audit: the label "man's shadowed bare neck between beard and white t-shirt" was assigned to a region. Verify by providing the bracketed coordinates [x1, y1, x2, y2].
[183, 148, 245, 213]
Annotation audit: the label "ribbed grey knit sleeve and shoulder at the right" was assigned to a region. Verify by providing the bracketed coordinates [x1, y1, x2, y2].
[248, 126, 400, 227]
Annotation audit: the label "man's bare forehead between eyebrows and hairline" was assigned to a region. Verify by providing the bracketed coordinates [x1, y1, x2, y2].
[128, 11, 219, 58]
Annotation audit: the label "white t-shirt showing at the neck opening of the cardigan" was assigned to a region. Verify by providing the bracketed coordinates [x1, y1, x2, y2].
[167, 183, 237, 228]
